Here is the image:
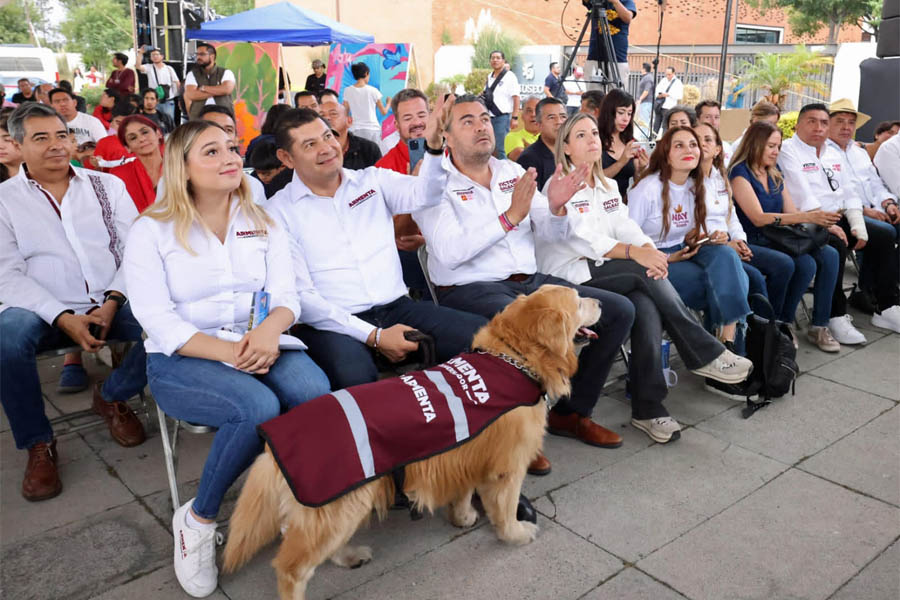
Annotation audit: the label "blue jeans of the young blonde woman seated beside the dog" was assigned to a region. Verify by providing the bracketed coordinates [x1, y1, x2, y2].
[147, 350, 329, 519]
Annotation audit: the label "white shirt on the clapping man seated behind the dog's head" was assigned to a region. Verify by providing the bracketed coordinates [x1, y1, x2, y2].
[413, 157, 568, 285]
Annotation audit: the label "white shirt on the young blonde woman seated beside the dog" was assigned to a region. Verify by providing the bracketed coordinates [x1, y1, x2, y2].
[124, 199, 300, 356]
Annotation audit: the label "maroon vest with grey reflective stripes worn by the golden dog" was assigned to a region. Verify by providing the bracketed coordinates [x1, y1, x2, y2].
[259, 353, 541, 506]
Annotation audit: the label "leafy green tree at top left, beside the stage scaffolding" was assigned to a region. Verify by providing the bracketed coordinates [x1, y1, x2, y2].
[62, 0, 132, 68]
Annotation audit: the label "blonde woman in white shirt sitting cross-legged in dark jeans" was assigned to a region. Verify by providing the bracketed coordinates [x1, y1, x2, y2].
[535, 113, 750, 443]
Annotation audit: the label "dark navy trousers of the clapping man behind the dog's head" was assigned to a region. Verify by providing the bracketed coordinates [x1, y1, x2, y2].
[438, 273, 634, 417]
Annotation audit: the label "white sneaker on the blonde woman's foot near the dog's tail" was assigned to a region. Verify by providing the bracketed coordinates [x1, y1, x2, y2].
[172, 498, 221, 598]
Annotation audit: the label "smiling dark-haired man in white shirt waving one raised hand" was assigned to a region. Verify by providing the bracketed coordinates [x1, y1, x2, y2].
[266, 107, 486, 389]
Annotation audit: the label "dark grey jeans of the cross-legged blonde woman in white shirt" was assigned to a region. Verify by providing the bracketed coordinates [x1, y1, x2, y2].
[583, 260, 725, 420]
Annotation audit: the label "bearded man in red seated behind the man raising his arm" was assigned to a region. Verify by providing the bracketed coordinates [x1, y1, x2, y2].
[375, 88, 429, 297]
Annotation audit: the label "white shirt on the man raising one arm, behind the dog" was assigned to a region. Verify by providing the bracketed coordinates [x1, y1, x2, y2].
[266, 154, 447, 342]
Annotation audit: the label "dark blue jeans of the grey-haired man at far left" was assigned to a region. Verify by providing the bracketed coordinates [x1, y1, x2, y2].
[0, 304, 147, 450]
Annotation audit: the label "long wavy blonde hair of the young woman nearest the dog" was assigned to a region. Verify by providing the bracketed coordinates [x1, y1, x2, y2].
[143, 120, 273, 254]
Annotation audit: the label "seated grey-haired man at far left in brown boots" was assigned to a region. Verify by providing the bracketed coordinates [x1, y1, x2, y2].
[0, 102, 147, 501]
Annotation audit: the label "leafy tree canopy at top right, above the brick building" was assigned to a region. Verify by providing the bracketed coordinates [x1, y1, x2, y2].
[747, 0, 884, 44]
